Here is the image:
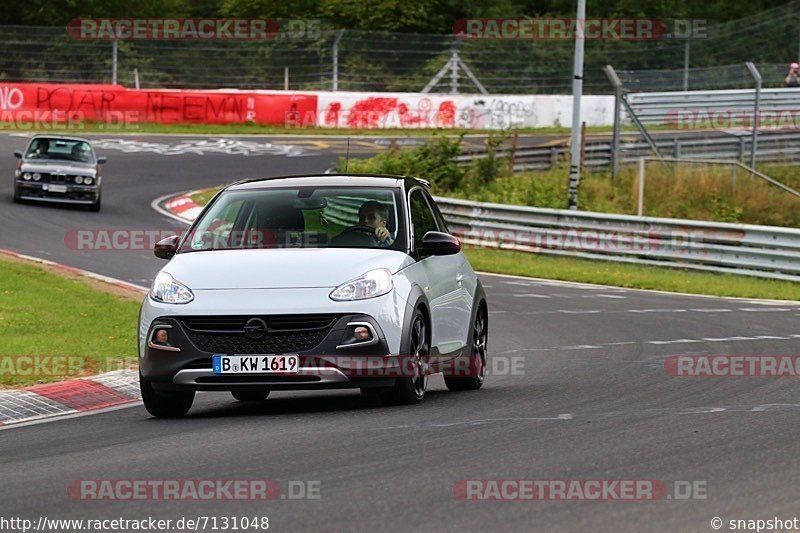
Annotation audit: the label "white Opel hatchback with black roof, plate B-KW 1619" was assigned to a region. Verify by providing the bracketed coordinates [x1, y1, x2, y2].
[139, 175, 488, 416]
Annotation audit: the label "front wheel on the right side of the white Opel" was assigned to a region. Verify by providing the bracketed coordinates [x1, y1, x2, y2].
[381, 309, 430, 405]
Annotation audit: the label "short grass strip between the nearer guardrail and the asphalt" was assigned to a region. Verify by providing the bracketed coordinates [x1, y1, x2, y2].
[465, 247, 800, 300]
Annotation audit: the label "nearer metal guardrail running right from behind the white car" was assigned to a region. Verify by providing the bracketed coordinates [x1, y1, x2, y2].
[436, 197, 800, 281]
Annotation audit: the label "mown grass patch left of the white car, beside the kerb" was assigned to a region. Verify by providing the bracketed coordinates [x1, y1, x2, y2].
[0, 258, 140, 387]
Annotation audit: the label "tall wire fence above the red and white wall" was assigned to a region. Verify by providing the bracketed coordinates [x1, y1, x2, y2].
[0, 0, 800, 94]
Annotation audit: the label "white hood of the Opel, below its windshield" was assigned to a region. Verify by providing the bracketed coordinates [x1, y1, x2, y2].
[163, 248, 413, 290]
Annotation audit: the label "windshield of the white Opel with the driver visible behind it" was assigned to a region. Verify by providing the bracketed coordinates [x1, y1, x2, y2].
[180, 187, 406, 252]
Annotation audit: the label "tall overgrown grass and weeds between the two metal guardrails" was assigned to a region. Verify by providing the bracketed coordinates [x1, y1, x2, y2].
[446, 162, 800, 227]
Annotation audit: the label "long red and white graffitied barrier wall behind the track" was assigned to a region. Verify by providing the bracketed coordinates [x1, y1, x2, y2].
[0, 83, 614, 129]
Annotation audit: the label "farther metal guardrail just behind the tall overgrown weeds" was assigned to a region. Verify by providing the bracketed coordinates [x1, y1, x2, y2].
[455, 131, 800, 172]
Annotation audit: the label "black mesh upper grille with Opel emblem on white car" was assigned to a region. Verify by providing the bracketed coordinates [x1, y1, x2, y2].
[181, 315, 337, 354]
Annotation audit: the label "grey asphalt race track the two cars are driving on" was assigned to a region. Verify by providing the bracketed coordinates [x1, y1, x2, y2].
[0, 132, 800, 532]
